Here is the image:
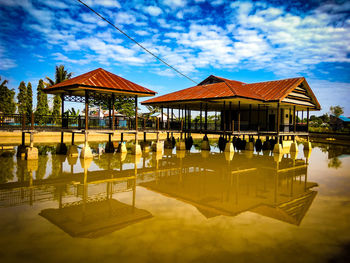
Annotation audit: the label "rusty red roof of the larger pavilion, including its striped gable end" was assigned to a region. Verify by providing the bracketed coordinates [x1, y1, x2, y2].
[142, 75, 320, 109]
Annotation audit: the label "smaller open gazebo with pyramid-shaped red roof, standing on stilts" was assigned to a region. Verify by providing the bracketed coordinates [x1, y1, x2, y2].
[44, 68, 156, 156]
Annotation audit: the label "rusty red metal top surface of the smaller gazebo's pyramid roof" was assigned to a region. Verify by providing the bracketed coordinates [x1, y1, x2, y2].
[45, 68, 156, 95]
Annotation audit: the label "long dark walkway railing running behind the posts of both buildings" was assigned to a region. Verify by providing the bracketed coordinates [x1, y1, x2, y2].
[0, 114, 307, 132]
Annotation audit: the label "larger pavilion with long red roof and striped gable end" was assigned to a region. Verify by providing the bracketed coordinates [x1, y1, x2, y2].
[141, 75, 320, 135]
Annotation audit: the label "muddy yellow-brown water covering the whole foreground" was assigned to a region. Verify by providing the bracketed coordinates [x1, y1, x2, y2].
[0, 144, 350, 262]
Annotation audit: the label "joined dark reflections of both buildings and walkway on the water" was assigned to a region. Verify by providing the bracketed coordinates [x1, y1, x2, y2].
[0, 146, 317, 238]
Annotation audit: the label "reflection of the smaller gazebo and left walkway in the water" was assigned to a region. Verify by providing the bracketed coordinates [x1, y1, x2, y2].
[0, 159, 152, 238]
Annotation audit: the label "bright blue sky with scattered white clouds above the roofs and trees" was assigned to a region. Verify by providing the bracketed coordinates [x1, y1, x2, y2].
[0, 0, 350, 116]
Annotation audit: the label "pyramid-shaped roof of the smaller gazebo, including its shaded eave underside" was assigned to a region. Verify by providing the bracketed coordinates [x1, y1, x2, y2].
[44, 68, 156, 97]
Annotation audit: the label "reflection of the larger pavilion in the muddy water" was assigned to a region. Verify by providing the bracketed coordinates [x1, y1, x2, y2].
[141, 154, 317, 225]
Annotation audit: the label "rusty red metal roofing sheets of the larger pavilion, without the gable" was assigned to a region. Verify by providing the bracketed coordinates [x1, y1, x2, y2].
[142, 75, 305, 104]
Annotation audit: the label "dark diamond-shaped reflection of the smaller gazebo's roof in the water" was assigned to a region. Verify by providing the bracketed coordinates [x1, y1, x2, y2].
[40, 199, 152, 238]
